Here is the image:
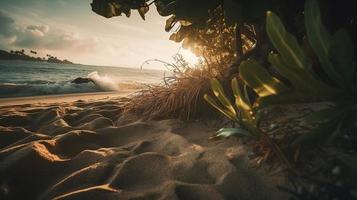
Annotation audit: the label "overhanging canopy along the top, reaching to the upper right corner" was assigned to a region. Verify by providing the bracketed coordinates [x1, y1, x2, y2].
[91, 0, 357, 66]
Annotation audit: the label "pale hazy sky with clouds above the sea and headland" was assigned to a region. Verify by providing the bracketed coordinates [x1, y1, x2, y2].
[0, 0, 194, 69]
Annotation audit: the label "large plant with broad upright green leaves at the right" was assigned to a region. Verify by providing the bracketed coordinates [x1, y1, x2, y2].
[246, 0, 356, 105]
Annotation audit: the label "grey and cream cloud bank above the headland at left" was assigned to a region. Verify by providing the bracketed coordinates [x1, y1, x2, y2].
[0, 11, 98, 53]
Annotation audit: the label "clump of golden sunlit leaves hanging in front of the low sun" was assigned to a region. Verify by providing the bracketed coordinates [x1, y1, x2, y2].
[170, 8, 241, 67]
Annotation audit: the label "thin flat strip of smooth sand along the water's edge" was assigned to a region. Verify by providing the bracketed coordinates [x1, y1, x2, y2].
[0, 89, 139, 107]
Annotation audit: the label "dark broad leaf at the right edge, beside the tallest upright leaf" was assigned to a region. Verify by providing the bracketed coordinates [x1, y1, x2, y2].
[329, 29, 356, 87]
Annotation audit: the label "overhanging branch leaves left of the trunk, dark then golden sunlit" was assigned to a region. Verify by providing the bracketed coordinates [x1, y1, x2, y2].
[92, 0, 264, 66]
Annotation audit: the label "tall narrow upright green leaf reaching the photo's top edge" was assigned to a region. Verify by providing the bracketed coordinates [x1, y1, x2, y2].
[304, 0, 343, 86]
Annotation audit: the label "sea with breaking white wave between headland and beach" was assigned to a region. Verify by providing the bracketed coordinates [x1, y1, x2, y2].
[0, 60, 165, 98]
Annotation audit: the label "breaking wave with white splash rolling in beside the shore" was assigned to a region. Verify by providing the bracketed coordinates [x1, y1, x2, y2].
[0, 71, 142, 98]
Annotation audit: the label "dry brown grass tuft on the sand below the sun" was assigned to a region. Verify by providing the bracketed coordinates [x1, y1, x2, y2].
[124, 55, 228, 120]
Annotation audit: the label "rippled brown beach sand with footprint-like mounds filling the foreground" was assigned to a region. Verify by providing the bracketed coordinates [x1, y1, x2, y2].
[0, 95, 286, 200]
